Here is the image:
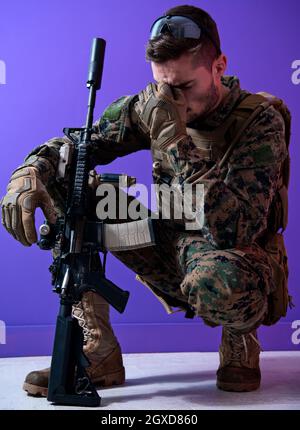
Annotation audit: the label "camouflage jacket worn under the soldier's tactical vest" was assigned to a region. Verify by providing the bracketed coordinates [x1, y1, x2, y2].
[27, 76, 287, 248]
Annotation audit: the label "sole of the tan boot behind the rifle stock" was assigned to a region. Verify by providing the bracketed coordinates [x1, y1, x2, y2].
[23, 367, 125, 397]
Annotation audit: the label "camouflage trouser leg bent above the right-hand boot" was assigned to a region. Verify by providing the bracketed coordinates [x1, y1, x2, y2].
[112, 220, 272, 333]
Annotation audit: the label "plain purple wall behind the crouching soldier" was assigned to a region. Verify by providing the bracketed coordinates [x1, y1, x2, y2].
[0, 0, 300, 356]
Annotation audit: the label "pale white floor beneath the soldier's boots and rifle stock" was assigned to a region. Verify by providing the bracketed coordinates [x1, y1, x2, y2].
[0, 351, 300, 410]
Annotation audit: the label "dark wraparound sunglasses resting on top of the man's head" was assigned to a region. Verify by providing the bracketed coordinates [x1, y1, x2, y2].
[150, 15, 221, 53]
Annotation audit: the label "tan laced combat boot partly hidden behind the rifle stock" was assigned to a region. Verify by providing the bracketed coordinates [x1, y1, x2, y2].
[23, 291, 125, 397]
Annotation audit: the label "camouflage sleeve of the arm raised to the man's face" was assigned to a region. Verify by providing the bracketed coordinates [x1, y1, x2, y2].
[193, 106, 287, 248]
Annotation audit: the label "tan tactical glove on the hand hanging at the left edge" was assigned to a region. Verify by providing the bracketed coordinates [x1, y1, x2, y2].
[1, 166, 56, 246]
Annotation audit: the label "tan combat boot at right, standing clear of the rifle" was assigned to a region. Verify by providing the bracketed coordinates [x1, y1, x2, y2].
[217, 327, 261, 391]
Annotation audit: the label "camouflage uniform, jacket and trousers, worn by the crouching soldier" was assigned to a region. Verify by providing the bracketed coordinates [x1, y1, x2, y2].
[24, 76, 287, 332]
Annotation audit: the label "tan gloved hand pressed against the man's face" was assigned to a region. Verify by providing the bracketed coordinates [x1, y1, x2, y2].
[135, 82, 187, 148]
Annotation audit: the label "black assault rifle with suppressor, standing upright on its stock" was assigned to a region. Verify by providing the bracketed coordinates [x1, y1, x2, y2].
[38, 38, 129, 406]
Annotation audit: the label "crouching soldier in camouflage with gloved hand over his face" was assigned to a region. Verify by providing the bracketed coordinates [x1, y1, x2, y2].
[2, 6, 287, 395]
